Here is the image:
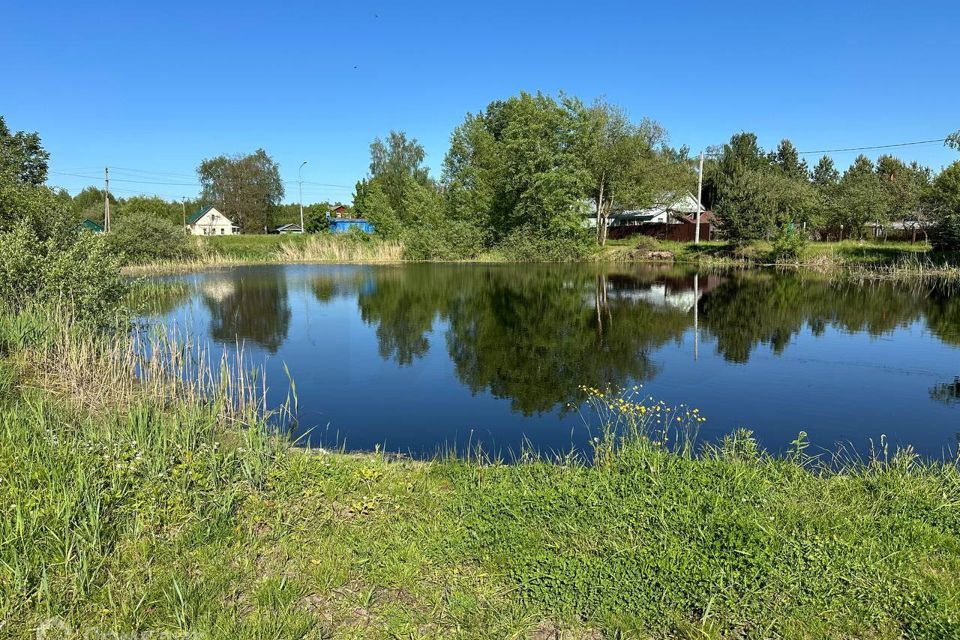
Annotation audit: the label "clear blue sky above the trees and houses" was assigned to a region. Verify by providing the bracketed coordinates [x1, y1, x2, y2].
[0, 0, 960, 201]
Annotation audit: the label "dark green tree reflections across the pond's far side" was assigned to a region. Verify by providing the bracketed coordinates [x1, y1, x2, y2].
[180, 265, 960, 414]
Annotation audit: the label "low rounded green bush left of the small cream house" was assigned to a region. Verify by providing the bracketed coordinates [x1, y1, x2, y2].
[107, 213, 196, 264]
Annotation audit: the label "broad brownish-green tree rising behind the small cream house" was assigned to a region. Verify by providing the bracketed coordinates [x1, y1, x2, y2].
[197, 149, 284, 233]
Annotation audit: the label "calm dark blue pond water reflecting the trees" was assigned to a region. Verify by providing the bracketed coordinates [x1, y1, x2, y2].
[144, 265, 960, 458]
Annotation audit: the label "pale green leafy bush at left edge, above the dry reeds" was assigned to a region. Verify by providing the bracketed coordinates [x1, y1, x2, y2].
[0, 224, 128, 324]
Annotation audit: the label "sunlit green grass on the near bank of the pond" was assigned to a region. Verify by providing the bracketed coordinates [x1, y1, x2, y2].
[0, 312, 960, 638]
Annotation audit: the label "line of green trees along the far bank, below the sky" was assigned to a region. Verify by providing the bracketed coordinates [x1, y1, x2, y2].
[0, 92, 960, 259]
